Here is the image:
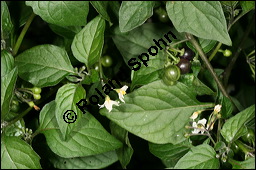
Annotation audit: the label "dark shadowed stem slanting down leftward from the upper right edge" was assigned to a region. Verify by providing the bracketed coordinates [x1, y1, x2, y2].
[223, 15, 255, 87]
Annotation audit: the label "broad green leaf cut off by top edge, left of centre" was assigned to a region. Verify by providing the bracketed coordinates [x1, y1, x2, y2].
[26, 1, 89, 26]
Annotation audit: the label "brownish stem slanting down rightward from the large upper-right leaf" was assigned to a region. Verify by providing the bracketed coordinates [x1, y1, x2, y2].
[186, 33, 231, 100]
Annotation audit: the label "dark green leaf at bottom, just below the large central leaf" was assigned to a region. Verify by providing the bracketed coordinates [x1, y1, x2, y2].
[149, 140, 192, 167]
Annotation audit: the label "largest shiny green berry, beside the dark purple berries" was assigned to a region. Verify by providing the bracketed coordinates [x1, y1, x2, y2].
[164, 65, 180, 82]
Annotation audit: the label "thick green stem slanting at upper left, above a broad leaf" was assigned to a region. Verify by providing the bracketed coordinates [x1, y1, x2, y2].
[12, 13, 36, 56]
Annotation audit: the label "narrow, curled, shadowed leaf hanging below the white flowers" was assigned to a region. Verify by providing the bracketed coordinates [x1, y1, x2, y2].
[110, 121, 133, 169]
